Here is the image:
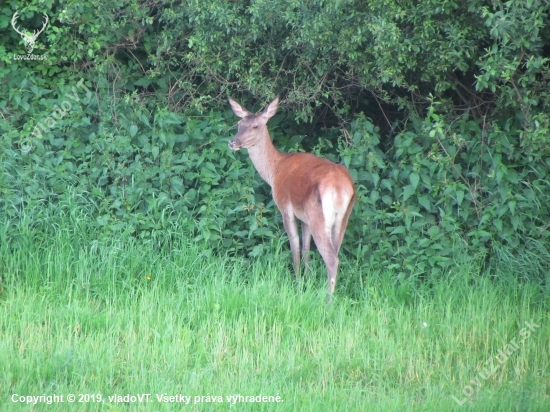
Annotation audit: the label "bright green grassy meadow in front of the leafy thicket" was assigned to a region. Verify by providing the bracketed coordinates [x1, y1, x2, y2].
[0, 214, 550, 411]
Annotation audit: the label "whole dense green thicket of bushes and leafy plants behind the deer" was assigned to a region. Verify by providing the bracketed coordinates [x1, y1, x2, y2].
[0, 0, 550, 275]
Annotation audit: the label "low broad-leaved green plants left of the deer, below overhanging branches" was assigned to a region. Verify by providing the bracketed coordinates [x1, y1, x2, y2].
[2, 89, 275, 251]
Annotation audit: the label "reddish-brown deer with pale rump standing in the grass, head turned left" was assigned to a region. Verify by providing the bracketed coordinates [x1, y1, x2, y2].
[228, 96, 356, 303]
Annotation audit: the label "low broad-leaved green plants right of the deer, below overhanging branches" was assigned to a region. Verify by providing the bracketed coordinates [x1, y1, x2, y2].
[347, 107, 550, 278]
